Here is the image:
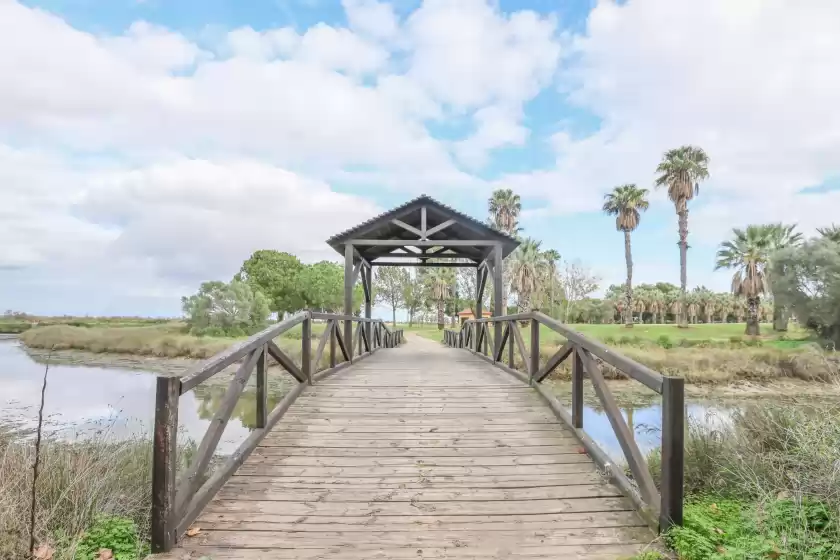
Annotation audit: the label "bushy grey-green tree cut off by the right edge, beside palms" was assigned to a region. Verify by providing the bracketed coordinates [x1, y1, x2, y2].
[772, 236, 840, 348]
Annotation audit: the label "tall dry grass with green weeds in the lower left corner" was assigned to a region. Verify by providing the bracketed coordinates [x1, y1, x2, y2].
[0, 426, 192, 560]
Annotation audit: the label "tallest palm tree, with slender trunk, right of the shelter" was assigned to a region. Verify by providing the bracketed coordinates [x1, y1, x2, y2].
[656, 146, 709, 326]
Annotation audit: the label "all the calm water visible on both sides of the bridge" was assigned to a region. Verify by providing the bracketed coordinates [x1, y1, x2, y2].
[0, 340, 733, 462]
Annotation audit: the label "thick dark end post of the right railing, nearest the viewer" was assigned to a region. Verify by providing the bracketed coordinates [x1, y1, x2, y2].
[659, 377, 685, 532]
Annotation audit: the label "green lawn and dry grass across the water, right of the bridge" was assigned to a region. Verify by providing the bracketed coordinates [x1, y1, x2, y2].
[411, 324, 840, 384]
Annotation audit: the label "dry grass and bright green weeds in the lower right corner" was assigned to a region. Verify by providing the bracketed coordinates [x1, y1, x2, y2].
[649, 404, 840, 560]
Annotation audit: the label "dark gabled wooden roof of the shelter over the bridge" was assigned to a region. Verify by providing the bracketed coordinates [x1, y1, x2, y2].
[327, 195, 519, 266]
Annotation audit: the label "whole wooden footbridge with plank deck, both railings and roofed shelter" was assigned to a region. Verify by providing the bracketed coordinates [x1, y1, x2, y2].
[146, 197, 684, 560]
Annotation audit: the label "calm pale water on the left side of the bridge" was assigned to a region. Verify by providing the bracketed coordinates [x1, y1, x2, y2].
[0, 340, 278, 453]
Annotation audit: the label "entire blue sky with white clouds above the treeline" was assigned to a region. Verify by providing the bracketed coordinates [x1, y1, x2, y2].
[0, 0, 840, 316]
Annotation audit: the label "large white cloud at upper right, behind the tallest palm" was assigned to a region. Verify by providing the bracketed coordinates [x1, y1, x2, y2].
[506, 0, 840, 238]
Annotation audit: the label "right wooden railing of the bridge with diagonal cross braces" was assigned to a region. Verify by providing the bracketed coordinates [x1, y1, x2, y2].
[443, 311, 685, 531]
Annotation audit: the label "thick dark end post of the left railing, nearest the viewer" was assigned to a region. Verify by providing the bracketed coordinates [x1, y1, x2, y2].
[151, 377, 181, 552]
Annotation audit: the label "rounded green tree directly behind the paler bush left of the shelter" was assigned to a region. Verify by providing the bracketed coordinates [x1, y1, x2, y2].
[236, 249, 306, 316]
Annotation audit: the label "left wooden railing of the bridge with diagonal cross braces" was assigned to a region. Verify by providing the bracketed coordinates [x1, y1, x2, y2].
[151, 311, 403, 552]
